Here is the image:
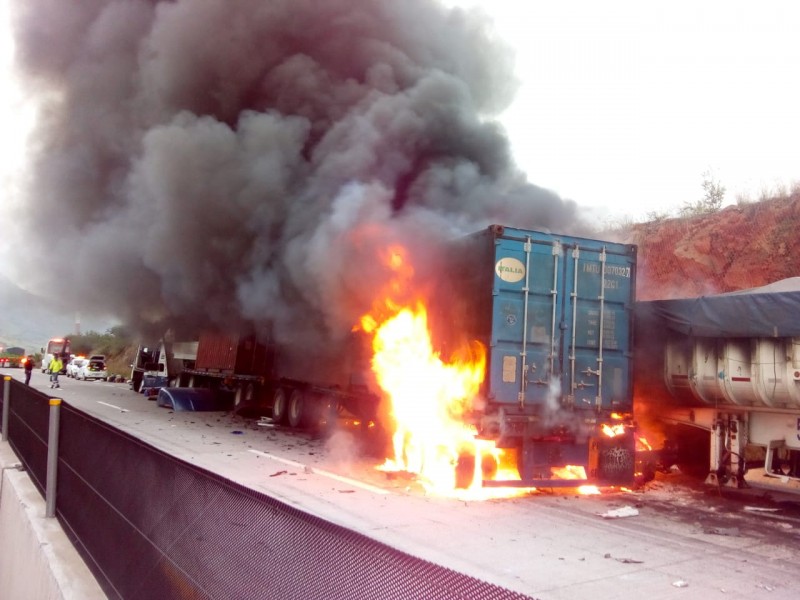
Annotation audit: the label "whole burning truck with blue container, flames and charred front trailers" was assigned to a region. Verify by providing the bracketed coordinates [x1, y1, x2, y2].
[140, 225, 636, 489]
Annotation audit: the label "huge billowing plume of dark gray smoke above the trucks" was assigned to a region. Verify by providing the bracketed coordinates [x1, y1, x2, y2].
[6, 0, 576, 340]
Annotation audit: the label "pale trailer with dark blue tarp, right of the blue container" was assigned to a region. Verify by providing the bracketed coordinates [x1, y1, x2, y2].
[636, 277, 800, 492]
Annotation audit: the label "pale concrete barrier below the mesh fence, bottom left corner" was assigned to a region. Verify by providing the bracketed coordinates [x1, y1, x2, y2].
[0, 442, 107, 600]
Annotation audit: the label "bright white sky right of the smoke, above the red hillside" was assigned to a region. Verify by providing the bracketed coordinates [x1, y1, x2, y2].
[445, 0, 800, 220]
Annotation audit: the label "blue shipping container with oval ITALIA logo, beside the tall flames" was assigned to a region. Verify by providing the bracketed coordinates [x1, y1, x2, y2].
[432, 225, 636, 486]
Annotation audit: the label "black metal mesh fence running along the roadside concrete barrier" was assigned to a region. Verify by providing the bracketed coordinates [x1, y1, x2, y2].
[4, 385, 527, 600]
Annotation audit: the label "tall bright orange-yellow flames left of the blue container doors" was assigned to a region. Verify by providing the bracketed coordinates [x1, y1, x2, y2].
[361, 248, 526, 499]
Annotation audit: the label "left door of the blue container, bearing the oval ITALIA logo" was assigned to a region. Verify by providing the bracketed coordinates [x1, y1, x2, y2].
[489, 232, 563, 408]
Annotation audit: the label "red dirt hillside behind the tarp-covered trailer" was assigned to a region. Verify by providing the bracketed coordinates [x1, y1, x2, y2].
[621, 192, 800, 300]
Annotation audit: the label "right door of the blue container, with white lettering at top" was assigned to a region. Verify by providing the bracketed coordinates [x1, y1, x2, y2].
[561, 240, 635, 411]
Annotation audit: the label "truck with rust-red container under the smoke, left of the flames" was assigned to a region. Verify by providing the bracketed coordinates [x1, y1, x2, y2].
[131, 332, 378, 427]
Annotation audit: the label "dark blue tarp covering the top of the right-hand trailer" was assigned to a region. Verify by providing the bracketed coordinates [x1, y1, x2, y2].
[635, 277, 800, 338]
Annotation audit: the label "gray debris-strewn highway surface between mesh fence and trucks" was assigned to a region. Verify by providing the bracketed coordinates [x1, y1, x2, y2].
[3, 369, 800, 600]
